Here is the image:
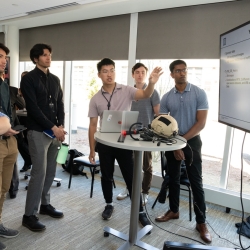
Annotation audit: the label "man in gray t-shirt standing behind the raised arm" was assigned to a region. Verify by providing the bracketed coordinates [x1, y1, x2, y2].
[117, 63, 160, 205]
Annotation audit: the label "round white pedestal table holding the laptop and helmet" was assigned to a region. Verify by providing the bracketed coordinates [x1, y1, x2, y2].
[95, 132, 186, 250]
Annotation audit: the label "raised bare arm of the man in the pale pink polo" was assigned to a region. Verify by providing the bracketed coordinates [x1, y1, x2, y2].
[135, 67, 163, 100]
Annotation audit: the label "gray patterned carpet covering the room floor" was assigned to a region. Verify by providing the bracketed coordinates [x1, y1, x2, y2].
[0, 156, 250, 250]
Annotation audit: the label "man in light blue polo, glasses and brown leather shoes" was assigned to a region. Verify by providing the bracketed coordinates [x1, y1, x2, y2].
[155, 60, 212, 243]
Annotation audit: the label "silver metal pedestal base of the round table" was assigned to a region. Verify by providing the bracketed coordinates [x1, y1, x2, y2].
[103, 226, 159, 250]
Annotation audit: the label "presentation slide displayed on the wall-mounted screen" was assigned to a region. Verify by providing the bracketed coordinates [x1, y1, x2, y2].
[219, 23, 250, 131]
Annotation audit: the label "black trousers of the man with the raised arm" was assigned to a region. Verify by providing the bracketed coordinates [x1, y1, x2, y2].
[97, 143, 143, 212]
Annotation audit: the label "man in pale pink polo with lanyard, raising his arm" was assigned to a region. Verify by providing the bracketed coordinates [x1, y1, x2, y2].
[88, 58, 162, 230]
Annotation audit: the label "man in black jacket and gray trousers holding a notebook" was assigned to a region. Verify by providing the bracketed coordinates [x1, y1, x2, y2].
[21, 44, 66, 232]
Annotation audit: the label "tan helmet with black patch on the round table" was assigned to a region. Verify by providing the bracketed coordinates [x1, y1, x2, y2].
[151, 115, 178, 137]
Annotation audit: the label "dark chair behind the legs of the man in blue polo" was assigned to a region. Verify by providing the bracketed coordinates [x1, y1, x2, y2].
[152, 152, 192, 221]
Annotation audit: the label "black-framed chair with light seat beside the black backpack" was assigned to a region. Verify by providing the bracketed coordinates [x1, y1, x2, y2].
[68, 150, 116, 198]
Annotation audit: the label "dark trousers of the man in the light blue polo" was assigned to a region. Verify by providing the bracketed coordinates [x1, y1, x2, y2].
[165, 135, 206, 224]
